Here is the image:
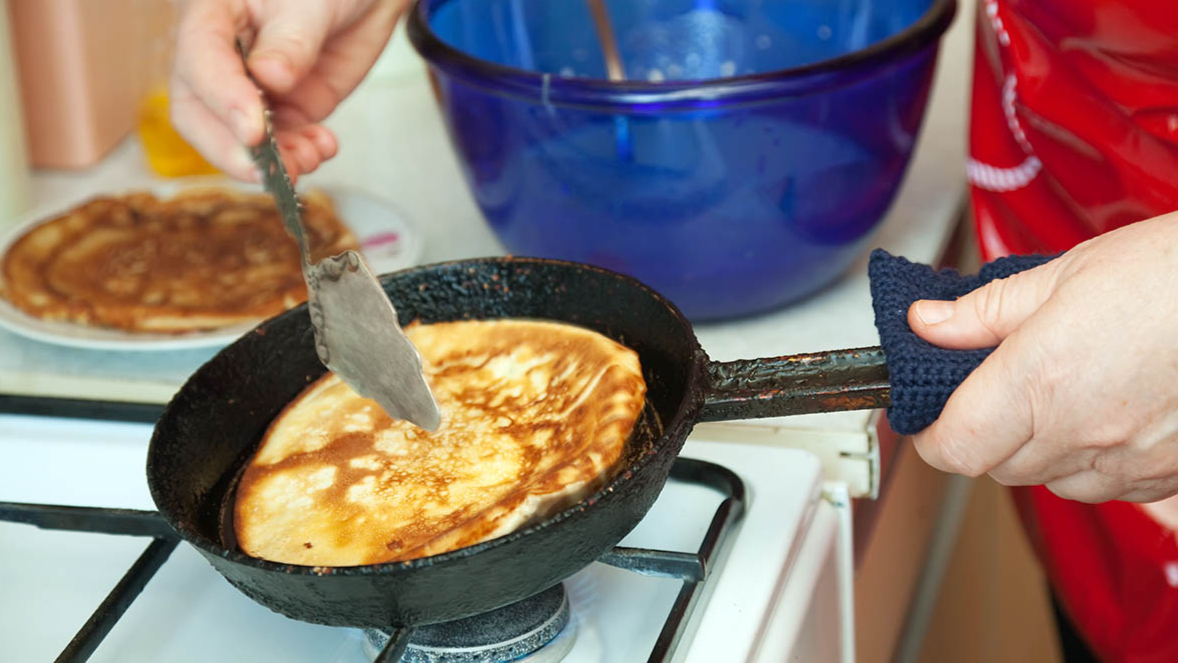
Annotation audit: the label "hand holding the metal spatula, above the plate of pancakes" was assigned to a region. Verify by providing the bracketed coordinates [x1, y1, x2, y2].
[170, 0, 409, 181]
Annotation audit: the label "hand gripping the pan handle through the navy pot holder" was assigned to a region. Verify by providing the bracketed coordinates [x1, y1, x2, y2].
[908, 213, 1178, 503]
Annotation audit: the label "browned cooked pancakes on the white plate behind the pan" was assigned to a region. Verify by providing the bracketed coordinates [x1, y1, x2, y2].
[0, 188, 357, 333]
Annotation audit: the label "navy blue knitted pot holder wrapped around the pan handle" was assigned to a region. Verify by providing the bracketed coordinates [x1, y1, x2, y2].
[867, 248, 1054, 435]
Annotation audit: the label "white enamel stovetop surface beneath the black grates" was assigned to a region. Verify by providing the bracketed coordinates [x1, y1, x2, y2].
[0, 415, 838, 663]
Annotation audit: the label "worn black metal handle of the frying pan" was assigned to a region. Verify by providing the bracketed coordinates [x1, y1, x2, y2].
[700, 347, 892, 422]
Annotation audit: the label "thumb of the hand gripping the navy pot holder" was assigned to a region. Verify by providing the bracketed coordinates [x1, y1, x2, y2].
[908, 260, 1058, 350]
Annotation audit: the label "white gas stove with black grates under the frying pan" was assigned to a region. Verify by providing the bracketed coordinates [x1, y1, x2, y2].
[0, 415, 853, 663]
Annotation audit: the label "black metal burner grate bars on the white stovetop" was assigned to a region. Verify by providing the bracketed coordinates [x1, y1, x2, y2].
[0, 458, 744, 663]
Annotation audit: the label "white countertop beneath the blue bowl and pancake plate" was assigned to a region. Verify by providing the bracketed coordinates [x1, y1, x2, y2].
[0, 8, 973, 433]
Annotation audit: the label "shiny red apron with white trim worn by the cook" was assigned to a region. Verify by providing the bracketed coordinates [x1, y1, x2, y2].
[967, 0, 1178, 663]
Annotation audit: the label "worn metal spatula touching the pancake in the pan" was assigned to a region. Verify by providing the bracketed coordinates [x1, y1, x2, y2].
[238, 41, 442, 431]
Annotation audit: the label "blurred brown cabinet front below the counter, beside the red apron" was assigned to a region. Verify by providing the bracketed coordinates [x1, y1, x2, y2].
[855, 440, 1061, 663]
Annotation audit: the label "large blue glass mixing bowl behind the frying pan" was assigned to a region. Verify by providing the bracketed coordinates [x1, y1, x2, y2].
[409, 0, 955, 320]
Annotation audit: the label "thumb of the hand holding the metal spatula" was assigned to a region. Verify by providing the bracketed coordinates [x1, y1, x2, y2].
[242, 1, 331, 94]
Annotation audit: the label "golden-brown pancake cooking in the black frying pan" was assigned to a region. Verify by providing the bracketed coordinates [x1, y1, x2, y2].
[233, 320, 646, 566]
